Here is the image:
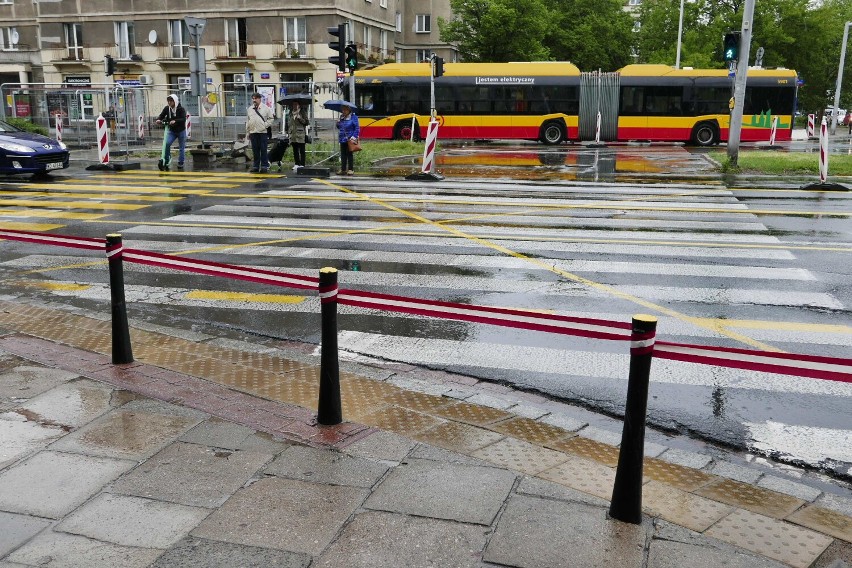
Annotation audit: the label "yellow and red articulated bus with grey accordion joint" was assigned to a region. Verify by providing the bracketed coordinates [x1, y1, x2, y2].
[348, 62, 797, 146]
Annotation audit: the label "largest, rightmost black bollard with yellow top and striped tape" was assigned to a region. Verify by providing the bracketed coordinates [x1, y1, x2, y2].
[609, 314, 657, 525]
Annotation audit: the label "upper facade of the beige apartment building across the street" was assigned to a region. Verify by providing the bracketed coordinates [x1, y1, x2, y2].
[0, 0, 456, 93]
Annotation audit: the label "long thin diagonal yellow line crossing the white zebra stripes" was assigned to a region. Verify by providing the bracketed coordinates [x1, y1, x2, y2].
[319, 180, 781, 352]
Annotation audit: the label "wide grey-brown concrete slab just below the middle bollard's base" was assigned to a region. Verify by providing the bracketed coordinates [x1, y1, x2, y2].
[263, 446, 389, 487]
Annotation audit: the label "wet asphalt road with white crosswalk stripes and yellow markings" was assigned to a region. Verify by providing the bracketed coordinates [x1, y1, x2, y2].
[0, 140, 852, 476]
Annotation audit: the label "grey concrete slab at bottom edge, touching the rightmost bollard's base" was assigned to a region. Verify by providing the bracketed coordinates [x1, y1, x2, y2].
[484, 495, 649, 568]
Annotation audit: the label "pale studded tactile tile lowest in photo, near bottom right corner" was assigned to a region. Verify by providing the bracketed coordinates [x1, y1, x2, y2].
[704, 509, 832, 568]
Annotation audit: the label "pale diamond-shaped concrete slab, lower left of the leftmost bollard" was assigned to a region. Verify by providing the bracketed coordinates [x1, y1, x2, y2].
[15, 379, 119, 428]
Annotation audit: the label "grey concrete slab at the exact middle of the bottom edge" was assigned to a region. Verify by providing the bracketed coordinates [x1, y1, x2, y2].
[316, 512, 487, 568]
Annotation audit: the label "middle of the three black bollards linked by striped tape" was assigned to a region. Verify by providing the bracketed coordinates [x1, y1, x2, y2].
[317, 267, 343, 426]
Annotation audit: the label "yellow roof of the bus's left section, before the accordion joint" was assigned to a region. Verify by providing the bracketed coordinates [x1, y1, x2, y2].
[355, 61, 580, 77]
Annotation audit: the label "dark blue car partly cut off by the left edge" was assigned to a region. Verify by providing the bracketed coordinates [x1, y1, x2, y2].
[0, 120, 69, 174]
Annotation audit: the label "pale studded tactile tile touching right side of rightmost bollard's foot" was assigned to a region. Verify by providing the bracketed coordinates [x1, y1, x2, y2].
[642, 481, 734, 532]
